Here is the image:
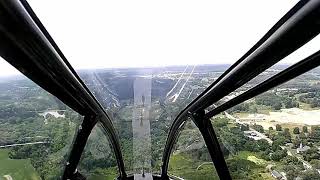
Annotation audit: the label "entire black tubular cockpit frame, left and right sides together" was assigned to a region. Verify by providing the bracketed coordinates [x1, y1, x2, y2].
[0, 0, 320, 179]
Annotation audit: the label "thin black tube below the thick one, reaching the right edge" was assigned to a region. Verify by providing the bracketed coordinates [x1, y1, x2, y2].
[205, 51, 320, 118]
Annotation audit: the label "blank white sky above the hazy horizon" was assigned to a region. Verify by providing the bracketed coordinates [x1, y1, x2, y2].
[0, 0, 320, 75]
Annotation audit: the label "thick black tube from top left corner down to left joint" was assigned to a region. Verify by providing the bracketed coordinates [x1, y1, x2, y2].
[0, 0, 92, 115]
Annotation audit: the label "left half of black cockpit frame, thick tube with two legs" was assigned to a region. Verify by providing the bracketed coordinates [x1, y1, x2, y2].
[0, 0, 127, 179]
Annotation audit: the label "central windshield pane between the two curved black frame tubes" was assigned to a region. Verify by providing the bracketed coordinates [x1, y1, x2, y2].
[23, 1, 296, 173]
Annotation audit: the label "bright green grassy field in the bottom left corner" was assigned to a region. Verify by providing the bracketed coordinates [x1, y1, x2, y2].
[0, 149, 40, 180]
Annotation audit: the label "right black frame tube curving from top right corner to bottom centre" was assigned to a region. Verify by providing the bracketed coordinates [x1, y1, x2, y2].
[161, 0, 320, 179]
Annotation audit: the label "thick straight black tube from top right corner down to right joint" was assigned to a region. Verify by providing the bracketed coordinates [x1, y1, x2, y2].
[192, 0, 320, 114]
